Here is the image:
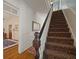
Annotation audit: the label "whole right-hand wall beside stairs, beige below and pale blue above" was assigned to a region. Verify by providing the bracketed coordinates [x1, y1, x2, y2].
[61, 0, 76, 46]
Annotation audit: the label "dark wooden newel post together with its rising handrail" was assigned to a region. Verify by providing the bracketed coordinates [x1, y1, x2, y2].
[33, 9, 51, 59]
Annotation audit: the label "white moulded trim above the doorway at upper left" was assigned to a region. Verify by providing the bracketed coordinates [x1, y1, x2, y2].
[3, 1, 19, 16]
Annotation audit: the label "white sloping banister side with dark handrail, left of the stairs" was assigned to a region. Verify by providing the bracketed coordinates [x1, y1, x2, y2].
[39, 8, 53, 59]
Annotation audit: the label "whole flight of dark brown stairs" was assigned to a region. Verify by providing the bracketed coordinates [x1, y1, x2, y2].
[43, 10, 76, 59]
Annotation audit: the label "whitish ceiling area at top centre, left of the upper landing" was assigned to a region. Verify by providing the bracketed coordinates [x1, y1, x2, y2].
[25, 0, 48, 12]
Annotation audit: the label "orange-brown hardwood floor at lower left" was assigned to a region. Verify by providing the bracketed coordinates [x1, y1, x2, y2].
[3, 45, 35, 59]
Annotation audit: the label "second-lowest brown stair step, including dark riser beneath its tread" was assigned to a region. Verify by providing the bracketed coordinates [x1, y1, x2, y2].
[46, 42, 76, 55]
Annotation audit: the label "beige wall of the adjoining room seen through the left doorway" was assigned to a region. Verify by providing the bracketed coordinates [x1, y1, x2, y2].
[3, 13, 19, 40]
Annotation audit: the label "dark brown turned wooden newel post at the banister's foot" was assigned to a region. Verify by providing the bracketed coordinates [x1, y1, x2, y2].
[33, 32, 40, 59]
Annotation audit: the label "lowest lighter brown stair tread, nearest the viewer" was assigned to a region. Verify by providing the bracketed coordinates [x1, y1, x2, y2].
[45, 49, 75, 59]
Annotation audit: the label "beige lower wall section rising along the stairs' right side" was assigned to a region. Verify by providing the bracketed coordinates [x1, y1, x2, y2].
[63, 9, 76, 46]
